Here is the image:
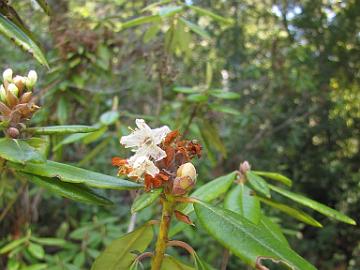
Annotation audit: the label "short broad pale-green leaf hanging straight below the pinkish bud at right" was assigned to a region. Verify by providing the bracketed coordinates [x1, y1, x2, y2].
[224, 184, 261, 224]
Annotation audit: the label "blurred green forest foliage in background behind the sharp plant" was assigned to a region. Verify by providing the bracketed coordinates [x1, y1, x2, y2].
[0, 0, 360, 270]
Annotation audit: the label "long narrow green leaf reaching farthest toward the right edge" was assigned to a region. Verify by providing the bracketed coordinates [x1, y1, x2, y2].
[269, 185, 356, 225]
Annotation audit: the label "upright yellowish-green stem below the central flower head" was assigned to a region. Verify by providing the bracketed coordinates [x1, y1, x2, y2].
[151, 197, 176, 270]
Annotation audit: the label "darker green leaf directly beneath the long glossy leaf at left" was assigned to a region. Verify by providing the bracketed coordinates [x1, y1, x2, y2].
[24, 174, 112, 205]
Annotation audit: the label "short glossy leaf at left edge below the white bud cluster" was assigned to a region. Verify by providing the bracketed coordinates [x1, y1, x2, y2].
[0, 138, 46, 164]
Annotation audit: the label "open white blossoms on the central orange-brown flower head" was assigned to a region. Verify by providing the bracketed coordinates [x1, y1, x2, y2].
[120, 119, 171, 178]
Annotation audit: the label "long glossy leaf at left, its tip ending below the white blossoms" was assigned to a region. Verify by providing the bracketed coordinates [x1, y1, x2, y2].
[9, 160, 142, 190]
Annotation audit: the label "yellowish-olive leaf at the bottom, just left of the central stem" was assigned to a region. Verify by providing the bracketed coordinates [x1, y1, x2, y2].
[91, 224, 154, 270]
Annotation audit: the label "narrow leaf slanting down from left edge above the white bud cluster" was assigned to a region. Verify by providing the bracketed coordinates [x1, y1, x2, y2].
[0, 14, 49, 67]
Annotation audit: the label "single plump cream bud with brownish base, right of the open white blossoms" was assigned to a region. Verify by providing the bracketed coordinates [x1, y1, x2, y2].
[172, 162, 196, 195]
